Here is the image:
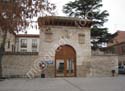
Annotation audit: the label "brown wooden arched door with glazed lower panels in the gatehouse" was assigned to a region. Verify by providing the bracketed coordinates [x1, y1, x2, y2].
[55, 45, 76, 77]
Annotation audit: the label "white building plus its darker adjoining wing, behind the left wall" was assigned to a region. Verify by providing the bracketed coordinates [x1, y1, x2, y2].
[0, 30, 39, 52]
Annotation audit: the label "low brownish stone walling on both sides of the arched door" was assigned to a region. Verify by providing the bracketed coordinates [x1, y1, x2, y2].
[2, 55, 118, 78]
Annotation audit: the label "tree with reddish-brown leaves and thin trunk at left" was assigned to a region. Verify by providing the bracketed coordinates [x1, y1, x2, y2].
[0, 0, 55, 77]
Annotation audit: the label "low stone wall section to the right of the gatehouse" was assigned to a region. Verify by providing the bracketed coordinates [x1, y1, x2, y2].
[90, 55, 118, 77]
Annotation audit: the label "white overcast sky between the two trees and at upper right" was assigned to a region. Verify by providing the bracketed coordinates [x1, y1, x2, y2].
[49, 0, 125, 33]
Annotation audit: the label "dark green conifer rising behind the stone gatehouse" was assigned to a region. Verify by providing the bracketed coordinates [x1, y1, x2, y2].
[63, 0, 110, 47]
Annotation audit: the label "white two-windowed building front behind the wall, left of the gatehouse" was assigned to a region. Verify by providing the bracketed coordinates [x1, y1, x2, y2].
[16, 34, 39, 52]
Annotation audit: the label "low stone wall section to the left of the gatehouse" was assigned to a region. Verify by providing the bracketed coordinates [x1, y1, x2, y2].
[2, 54, 38, 77]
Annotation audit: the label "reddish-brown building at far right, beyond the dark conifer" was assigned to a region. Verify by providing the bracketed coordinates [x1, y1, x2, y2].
[106, 31, 125, 55]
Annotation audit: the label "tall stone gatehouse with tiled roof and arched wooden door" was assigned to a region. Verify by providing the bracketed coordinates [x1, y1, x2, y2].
[39, 17, 91, 76]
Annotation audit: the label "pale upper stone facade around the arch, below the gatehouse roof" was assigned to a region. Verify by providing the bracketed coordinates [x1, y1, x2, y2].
[39, 26, 91, 65]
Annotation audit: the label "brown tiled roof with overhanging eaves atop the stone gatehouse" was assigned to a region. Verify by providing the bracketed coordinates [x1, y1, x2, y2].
[38, 16, 92, 27]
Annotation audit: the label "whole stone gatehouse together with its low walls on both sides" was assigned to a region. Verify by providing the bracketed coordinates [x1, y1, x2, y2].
[2, 16, 118, 77]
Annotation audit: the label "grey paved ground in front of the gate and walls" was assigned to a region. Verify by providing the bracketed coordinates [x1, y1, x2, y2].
[0, 77, 125, 91]
